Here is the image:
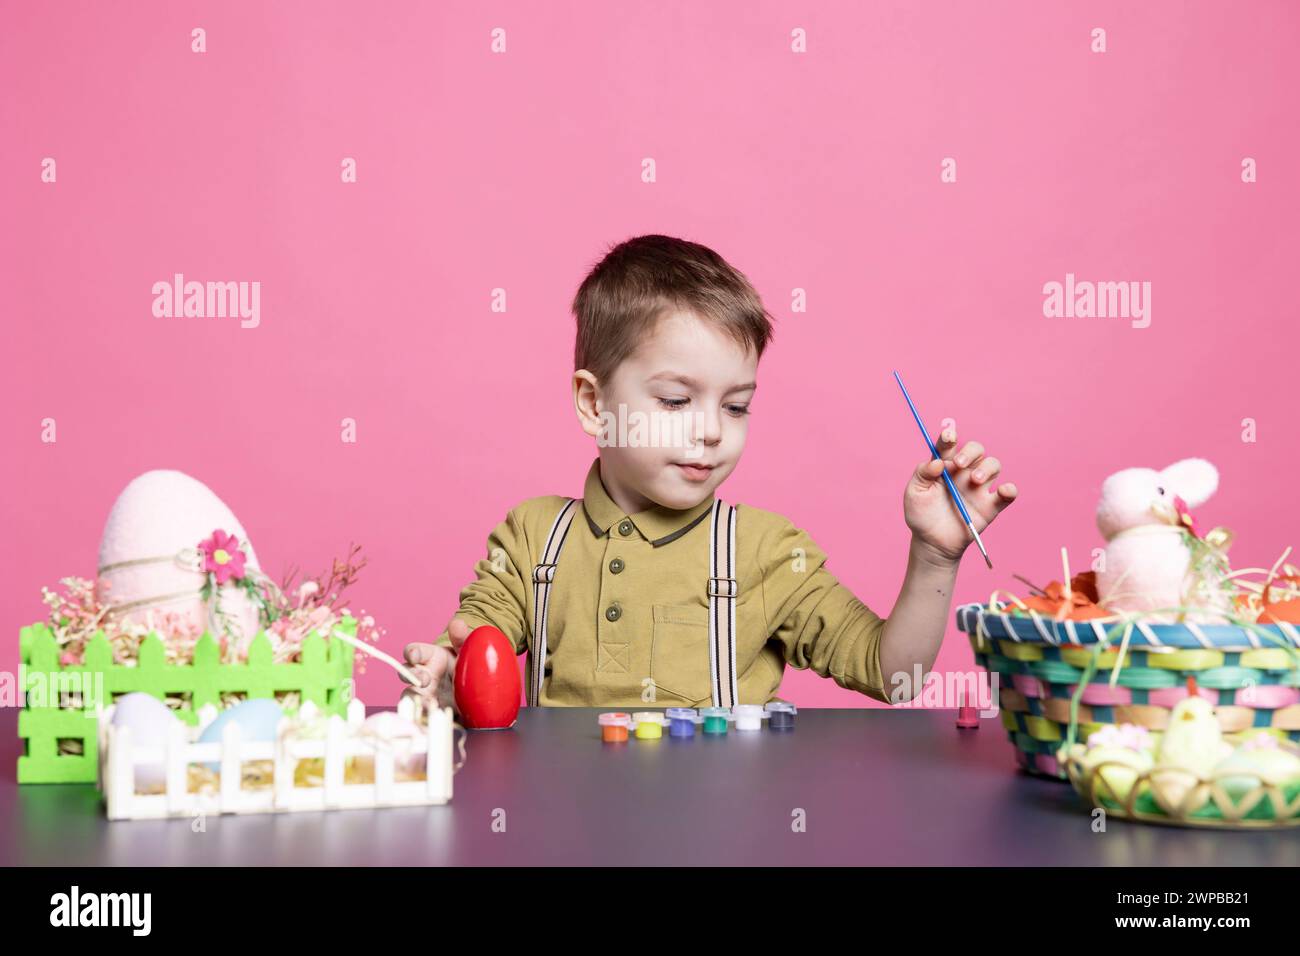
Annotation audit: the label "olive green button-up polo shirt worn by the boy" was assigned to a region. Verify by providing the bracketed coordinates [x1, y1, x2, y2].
[438, 458, 889, 708]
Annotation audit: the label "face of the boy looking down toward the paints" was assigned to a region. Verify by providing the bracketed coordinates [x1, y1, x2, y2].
[580, 312, 758, 514]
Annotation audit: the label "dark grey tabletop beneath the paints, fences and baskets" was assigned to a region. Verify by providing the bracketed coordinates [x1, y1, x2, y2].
[0, 708, 1300, 866]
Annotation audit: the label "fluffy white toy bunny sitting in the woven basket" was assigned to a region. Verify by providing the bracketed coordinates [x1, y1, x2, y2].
[1097, 458, 1231, 624]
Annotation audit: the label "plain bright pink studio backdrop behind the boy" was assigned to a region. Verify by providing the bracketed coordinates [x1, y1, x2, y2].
[0, 0, 1300, 706]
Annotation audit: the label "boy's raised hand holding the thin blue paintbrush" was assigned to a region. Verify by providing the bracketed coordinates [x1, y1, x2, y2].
[902, 428, 1018, 563]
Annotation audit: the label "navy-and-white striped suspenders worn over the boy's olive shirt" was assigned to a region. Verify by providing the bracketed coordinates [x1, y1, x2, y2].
[528, 498, 740, 708]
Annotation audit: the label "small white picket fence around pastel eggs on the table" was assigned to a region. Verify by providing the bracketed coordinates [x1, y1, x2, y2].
[99, 700, 455, 819]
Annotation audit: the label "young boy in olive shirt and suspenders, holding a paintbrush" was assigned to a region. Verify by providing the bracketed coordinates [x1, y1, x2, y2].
[406, 235, 1017, 708]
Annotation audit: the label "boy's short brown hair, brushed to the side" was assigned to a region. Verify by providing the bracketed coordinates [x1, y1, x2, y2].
[573, 235, 772, 382]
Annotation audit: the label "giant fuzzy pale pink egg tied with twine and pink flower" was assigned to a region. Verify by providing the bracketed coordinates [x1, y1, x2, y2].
[98, 470, 259, 640]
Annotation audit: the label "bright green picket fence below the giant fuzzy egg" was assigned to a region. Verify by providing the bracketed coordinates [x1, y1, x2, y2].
[18, 617, 356, 783]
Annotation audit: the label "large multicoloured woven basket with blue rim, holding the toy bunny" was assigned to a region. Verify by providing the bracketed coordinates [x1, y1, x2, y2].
[957, 604, 1300, 780]
